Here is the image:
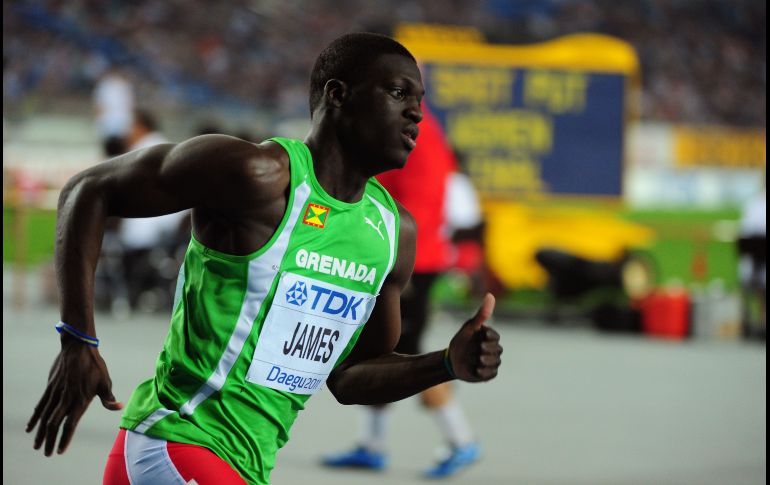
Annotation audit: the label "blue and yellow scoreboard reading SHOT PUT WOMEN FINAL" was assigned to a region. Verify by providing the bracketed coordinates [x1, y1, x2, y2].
[397, 24, 639, 200]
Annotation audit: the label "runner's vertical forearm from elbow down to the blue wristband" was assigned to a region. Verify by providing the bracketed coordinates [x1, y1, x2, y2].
[55, 174, 107, 336]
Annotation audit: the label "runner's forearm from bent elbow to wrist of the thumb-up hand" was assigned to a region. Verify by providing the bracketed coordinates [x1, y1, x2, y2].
[328, 351, 451, 404]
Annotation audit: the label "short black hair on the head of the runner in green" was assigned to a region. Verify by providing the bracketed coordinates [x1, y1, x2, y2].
[310, 32, 416, 117]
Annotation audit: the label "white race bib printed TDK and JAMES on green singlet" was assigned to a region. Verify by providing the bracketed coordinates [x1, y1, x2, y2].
[246, 273, 376, 394]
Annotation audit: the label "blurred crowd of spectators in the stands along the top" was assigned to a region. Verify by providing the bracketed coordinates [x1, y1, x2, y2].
[3, 0, 767, 126]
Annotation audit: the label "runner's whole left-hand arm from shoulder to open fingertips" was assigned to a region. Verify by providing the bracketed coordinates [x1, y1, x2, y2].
[27, 135, 288, 456]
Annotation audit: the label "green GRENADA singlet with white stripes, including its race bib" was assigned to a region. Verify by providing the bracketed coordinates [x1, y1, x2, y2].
[121, 138, 399, 484]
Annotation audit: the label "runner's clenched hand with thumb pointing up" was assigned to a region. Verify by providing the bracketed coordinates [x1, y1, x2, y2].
[449, 293, 503, 382]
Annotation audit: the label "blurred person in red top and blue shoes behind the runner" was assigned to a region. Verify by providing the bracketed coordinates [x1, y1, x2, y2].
[323, 105, 480, 478]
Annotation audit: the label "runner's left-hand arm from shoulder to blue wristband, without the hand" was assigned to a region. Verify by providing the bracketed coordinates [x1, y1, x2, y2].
[56, 135, 288, 335]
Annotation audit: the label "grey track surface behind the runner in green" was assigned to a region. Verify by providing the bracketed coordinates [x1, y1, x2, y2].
[3, 270, 767, 485]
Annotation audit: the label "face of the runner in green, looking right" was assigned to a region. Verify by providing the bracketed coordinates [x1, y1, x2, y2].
[343, 54, 425, 175]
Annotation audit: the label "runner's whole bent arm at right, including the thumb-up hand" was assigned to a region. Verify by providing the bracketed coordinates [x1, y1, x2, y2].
[327, 204, 502, 404]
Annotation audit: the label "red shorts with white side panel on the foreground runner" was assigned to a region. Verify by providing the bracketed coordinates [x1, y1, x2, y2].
[102, 429, 246, 485]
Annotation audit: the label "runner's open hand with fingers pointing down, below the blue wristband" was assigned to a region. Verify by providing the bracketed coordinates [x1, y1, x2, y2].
[27, 339, 123, 456]
